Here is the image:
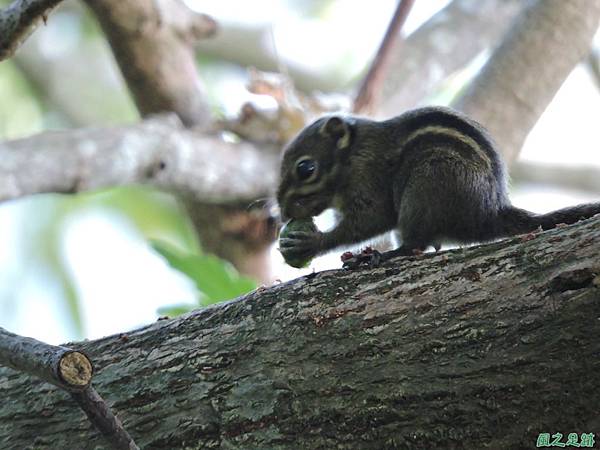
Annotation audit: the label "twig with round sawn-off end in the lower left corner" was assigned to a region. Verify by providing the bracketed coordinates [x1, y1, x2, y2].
[0, 328, 138, 450]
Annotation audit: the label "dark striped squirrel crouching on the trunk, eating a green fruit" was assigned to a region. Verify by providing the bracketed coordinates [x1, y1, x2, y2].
[277, 107, 600, 264]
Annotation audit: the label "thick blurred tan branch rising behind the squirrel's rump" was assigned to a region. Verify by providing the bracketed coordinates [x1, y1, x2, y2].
[453, 0, 600, 162]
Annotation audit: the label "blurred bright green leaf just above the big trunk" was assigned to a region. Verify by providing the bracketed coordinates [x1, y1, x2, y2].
[152, 241, 256, 306]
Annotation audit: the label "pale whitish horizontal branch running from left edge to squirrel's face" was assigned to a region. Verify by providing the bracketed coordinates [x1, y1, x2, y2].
[0, 116, 278, 204]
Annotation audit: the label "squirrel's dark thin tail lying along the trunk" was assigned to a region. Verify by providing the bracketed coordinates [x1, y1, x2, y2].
[499, 202, 600, 237]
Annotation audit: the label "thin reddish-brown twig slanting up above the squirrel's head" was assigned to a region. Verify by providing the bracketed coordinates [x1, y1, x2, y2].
[353, 0, 414, 113]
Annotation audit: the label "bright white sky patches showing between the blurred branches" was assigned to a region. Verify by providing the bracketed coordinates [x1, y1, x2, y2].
[0, 0, 600, 343]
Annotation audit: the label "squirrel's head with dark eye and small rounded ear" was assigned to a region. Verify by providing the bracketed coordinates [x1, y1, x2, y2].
[277, 116, 354, 220]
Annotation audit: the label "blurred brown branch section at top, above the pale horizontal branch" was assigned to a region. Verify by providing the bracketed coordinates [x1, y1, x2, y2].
[86, 0, 216, 126]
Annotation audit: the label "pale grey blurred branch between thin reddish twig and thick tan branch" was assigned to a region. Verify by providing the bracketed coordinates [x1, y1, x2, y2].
[378, 0, 531, 116]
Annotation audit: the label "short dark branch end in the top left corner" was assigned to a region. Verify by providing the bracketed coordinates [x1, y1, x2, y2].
[0, 0, 62, 61]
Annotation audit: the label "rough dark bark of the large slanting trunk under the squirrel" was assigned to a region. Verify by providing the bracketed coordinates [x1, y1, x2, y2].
[0, 217, 600, 450]
